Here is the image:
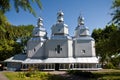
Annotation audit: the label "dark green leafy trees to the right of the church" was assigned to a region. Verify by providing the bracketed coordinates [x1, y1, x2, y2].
[92, 24, 120, 66]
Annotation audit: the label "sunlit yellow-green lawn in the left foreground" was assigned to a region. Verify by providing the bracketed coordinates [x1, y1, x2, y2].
[3, 71, 66, 80]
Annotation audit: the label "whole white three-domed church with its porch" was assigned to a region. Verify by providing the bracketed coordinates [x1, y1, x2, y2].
[5, 11, 99, 70]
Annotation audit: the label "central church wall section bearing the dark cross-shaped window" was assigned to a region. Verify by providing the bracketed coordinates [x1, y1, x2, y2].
[45, 39, 68, 58]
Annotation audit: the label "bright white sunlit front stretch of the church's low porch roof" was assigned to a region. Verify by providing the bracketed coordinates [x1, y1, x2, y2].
[23, 57, 99, 64]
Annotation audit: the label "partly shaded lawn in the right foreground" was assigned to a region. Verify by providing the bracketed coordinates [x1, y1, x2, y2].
[68, 69, 120, 80]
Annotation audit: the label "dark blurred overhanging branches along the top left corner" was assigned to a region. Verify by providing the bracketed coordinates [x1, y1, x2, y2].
[0, 0, 42, 16]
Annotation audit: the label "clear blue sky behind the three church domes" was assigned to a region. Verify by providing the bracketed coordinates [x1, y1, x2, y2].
[5, 0, 113, 36]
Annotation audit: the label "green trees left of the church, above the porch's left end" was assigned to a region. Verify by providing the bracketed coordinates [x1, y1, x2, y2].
[0, 25, 33, 61]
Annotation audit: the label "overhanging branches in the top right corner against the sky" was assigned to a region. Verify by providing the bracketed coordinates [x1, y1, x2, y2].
[112, 0, 120, 25]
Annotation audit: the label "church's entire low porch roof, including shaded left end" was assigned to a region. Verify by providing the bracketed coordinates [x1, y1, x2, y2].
[4, 54, 99, 64]
